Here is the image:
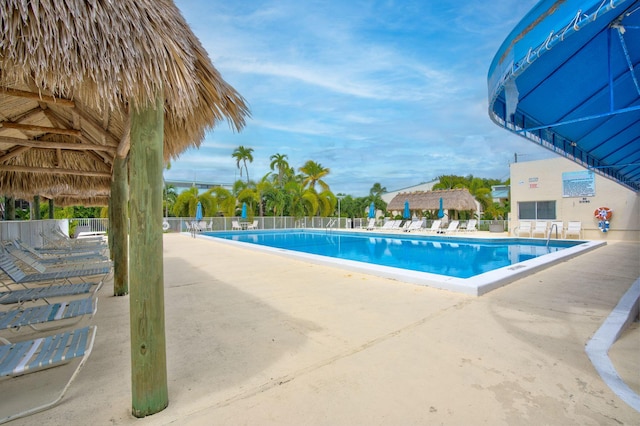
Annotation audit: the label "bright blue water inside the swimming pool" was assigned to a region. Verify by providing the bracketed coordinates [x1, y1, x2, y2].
[205, 230, 580, 278]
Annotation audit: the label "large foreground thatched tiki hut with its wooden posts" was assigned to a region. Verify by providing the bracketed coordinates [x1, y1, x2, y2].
[0, 0, 248, 417]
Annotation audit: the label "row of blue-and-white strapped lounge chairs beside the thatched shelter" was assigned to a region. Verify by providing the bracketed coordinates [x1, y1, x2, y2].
[0, 240, 101, 423]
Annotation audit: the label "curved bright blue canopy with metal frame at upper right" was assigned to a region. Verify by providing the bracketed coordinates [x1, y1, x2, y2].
[488, 0, 640, 191]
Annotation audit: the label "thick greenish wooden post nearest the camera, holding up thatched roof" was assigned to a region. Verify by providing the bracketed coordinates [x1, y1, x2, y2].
[129, 94, 169, 417]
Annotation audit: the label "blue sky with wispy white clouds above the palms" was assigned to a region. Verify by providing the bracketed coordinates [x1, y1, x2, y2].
[165, 0, 553, 196]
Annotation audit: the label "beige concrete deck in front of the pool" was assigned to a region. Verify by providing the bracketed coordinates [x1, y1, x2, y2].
[5, 234, 640, 425]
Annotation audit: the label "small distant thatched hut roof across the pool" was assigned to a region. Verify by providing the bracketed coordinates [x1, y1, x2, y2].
[387, 188, 477, 211]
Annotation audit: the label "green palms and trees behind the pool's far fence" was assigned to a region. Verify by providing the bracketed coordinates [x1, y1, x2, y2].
[164, 146, 508, 219]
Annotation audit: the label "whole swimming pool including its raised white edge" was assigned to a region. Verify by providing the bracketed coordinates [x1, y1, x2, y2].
[204, 229, 600, 295]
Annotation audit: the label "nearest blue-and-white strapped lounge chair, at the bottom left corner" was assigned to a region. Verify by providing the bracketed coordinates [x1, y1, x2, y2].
[0, 326, 97, 423]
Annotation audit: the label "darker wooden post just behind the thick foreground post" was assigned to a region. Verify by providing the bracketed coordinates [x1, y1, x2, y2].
[109, 157, 129, 296]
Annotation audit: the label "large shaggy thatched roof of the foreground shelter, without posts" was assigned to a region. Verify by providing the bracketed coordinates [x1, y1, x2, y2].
[0, 0, 249, 203]
